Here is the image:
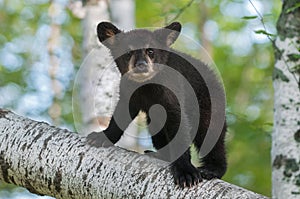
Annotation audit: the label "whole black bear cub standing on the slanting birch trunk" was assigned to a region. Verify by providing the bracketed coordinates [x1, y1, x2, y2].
[87, 22, 227, 187]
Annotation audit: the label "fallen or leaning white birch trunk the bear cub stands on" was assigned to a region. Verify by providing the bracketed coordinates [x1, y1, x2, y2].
[0, 109, 266, 199]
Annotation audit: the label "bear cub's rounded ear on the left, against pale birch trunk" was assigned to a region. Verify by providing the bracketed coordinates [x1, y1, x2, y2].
[97, 22, 122, 47]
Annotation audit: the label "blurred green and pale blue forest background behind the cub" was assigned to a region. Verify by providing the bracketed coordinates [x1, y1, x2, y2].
[0, 0, 281, 199]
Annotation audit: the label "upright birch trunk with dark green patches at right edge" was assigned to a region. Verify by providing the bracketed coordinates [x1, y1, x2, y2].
[272, 0, 300, 199]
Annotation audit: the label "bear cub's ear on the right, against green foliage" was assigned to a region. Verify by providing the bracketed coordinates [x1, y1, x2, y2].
[154, 22, 181, 46]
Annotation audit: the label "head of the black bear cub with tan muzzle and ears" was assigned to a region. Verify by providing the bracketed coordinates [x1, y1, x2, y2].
[97, 22, 181, 82]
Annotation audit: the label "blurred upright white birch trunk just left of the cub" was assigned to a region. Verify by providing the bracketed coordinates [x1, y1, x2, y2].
[73, 0, 120, 135]
